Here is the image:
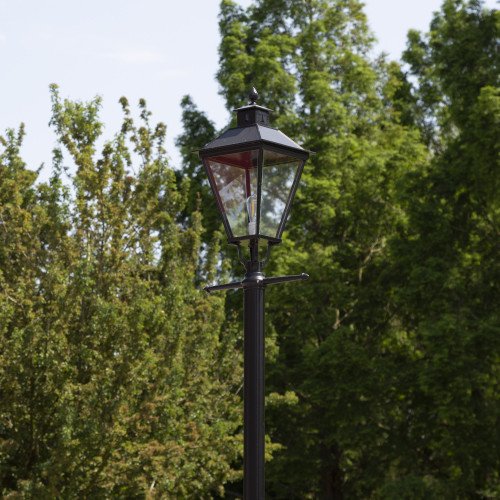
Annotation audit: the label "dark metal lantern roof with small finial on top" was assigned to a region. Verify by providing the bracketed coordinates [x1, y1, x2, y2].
[199, 89, 309, 155]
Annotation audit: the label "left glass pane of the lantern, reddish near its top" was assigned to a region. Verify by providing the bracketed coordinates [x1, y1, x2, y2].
[208, 150, 259, 236]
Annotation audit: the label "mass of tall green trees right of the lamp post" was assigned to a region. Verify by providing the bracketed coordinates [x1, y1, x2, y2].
[178, 0, 499, 498]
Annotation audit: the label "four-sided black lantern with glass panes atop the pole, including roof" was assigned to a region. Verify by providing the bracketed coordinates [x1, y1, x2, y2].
[199, 92, 309, 244]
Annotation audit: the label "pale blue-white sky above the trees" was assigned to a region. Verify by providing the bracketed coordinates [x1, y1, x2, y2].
[0, 0, 495, 179]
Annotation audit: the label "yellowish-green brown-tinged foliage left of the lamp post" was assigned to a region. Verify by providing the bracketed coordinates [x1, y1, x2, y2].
[0, 86, 241, 498]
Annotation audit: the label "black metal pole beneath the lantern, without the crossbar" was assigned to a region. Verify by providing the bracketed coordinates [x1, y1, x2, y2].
[242, 240, 265, 500]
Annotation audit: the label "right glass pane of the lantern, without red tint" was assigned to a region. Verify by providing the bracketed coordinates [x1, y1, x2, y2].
[260, 150, 302, 237]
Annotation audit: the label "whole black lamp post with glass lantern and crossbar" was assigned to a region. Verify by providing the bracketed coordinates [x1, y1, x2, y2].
[199, 89, 310, 500]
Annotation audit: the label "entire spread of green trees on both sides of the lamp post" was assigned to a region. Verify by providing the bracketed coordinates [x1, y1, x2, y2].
[0, 0, 500, 499]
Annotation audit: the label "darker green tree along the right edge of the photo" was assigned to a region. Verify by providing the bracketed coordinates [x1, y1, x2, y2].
[380, 0, 500, 498]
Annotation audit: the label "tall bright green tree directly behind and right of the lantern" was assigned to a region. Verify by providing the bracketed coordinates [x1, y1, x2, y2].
[213, 0, 426, 498]
